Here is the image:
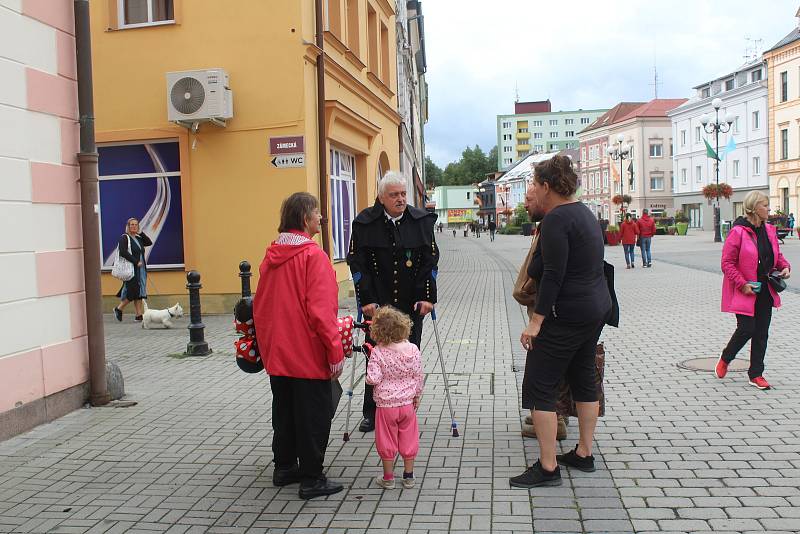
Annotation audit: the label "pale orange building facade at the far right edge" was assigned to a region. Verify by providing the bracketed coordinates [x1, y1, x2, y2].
[764, 19, 800, 216]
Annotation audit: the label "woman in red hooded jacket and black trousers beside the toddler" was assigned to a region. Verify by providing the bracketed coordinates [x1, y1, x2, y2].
[253, 193, 344, 499]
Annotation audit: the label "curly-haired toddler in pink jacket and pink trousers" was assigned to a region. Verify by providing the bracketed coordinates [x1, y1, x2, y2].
[367, 306, 423, 489]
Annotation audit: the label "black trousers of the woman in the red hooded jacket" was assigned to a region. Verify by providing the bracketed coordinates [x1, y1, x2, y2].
[269, 376, 333, 482]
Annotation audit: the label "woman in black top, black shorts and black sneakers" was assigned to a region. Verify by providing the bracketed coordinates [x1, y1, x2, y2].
[510, 156, 611, 488]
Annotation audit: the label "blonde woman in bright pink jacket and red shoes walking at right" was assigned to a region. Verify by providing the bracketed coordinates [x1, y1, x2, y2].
[714, 191, 791, 389]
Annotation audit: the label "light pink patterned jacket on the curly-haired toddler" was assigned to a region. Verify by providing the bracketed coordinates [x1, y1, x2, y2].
[367, 341, 423, 408]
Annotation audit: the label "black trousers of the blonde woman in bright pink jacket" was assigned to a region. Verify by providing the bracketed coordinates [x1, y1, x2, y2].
[722, 288, 773, 378]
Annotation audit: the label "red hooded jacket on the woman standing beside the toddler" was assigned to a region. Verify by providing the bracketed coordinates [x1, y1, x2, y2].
[253, 232, 344, 380]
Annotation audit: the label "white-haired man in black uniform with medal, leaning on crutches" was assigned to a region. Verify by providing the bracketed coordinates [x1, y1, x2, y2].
[347, 171, 439, 432]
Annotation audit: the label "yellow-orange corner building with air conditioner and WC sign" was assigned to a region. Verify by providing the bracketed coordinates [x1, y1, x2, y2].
[91, 0, 400, 313]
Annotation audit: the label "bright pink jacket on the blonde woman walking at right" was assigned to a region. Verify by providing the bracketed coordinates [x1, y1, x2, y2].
[722, 223, 789, 317]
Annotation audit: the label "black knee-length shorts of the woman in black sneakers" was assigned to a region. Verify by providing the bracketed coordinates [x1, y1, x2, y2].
[522, 318, 604, 412]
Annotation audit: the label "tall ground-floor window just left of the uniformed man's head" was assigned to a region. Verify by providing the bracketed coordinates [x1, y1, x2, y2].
[330, 148, 358, 260]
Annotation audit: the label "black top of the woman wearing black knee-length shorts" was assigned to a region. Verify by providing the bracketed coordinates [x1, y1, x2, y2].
[528, 202, 611, 323]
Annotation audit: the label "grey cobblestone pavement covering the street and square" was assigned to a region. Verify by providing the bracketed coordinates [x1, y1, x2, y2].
[0, 233, 800, 533]
